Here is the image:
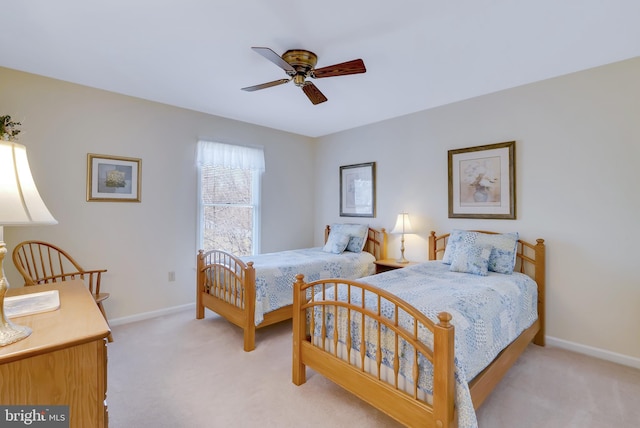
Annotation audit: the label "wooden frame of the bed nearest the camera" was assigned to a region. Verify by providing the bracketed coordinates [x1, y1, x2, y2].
[292, 232, 545, 428]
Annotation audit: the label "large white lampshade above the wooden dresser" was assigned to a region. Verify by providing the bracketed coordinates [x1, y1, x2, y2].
[0, 141, 58, 226]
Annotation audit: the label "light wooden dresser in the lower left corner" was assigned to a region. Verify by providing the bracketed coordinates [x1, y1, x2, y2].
[0, 281, 109, 428]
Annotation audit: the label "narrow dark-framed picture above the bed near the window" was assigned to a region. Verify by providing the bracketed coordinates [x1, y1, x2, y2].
[340, 162, 376, 217]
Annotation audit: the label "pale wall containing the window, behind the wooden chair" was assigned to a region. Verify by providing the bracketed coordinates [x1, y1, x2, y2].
[0, 68, 314, 319]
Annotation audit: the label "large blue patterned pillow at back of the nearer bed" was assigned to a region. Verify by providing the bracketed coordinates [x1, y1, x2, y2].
[442, 230, 518, 274]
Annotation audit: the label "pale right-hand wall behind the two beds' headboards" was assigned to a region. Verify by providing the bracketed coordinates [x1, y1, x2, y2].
[315, 58, 640, 366]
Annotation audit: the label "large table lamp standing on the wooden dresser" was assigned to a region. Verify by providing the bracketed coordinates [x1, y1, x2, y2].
[0, 140, 58, 346]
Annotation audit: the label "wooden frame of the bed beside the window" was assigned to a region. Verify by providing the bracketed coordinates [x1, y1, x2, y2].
[196, 226, 387, 352]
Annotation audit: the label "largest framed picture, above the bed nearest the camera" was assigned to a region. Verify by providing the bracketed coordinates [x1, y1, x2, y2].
[449, 141, 516, 220]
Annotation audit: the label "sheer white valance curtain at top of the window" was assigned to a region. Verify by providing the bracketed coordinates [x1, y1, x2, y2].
[197, 141, 264, 172]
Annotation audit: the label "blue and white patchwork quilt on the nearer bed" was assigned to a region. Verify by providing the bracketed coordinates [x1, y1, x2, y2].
[314, 261, 537, 428]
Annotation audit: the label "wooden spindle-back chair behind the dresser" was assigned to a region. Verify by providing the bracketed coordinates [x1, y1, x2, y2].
[13, 241, 113, 342]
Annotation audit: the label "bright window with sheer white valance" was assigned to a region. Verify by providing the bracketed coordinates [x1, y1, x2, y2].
[197, 141, 264, 256]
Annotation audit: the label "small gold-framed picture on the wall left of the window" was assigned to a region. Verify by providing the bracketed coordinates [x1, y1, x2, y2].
[87, 153, 142, 202]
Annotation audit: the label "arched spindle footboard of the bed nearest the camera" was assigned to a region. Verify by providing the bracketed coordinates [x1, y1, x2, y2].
[292, 275, 455, 428]
